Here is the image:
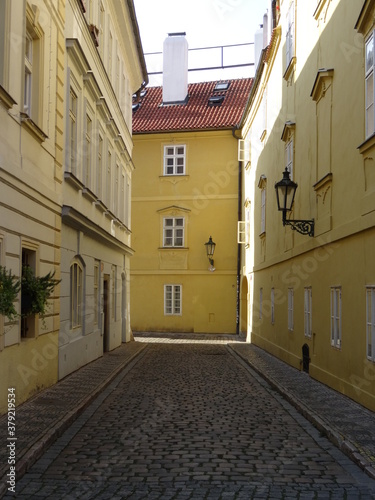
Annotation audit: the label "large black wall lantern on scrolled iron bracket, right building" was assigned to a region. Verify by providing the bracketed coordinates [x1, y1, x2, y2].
[275, 168, 314, 236]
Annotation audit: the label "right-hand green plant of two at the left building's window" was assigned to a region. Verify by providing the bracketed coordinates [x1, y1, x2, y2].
[21, 266, 61, 317]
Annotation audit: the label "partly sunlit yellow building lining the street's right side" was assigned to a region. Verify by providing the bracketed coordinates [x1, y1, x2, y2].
[241, 0, 375, 409]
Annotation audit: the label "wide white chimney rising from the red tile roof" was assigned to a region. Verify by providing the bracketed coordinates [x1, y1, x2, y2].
[163, 33, 188, 104]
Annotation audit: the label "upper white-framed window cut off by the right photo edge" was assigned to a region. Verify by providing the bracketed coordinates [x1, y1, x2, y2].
[365, 30, 375, 139]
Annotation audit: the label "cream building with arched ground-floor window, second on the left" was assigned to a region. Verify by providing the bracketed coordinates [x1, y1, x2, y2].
[59, 0, 147, 378]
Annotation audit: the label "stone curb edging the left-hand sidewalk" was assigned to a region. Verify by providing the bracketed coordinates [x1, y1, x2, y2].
[0, 343, 147, 498]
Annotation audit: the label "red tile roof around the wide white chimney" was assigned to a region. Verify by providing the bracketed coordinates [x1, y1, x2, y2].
[133, 78, 253, 134]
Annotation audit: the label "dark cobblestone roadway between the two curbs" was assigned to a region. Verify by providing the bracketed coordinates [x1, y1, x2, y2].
[6, 339, 375, 500]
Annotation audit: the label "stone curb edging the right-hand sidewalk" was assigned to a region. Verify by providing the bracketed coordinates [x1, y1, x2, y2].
[228, 344, 375, 479]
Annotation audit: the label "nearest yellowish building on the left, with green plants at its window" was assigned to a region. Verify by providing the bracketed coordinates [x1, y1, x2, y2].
[0, 0, 65, 413]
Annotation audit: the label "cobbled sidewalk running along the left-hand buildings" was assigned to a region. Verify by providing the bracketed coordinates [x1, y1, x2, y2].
[0, 342, 146, 498]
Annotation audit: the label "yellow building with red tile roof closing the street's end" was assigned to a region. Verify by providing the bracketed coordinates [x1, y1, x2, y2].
[131, 69, 251, 334]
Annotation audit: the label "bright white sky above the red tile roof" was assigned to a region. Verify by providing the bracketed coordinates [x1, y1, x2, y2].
[134, 0, 270, 86]
